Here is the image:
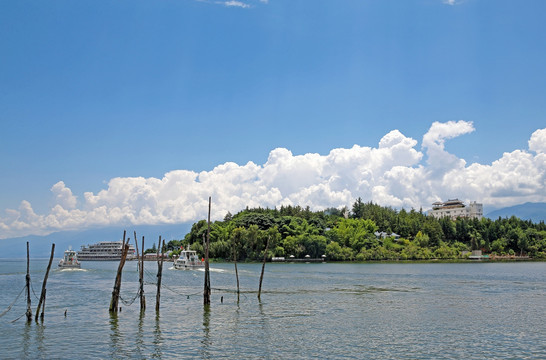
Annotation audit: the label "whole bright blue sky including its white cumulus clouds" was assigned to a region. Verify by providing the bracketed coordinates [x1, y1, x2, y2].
[0, 0, 546, 238]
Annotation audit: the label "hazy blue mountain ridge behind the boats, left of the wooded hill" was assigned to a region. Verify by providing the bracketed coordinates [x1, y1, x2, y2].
[0, 223, 192, 259]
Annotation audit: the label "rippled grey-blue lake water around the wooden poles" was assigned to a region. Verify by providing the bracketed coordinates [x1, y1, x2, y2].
[0, 260, 546, 359]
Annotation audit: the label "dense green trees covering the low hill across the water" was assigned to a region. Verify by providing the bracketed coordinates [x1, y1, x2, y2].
[163, 198, 546, 261]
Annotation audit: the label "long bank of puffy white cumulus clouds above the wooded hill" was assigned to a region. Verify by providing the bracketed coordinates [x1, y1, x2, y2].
[0, 124, 546, 238]
